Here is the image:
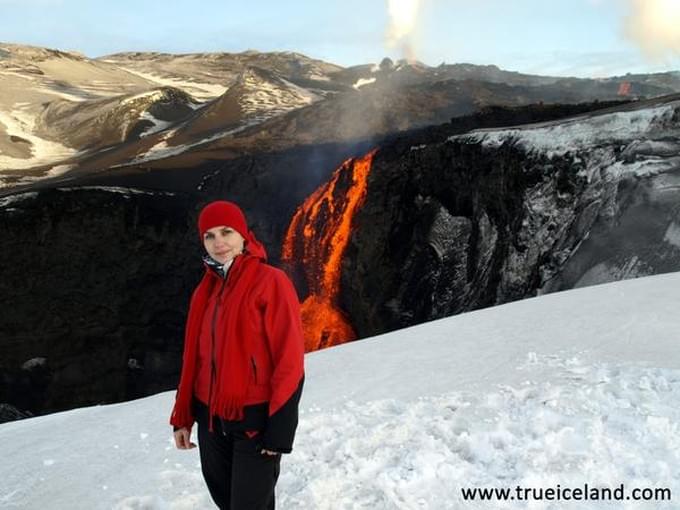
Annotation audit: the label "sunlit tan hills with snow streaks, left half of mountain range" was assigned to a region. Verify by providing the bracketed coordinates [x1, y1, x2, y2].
[0, 43, 340, 183]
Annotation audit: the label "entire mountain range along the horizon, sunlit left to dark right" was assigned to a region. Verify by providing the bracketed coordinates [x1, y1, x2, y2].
[0, 43, 680, 187]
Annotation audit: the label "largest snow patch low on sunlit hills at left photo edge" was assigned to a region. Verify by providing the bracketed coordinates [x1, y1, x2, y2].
[0, 110, 77, 170]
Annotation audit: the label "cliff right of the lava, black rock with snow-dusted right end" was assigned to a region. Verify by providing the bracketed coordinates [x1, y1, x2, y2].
[342, 97, 680, 337]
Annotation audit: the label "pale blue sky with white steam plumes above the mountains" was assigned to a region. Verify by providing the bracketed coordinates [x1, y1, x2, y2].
[0, 0, 680, 77]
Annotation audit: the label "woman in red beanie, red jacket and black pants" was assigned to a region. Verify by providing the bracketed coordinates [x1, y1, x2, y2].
[170, 201, 304, 510]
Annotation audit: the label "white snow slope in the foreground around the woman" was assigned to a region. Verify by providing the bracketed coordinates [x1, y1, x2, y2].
[0, 273, 680, 510]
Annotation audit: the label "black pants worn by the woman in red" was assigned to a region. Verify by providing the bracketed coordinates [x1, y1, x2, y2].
[194, 401, 281, 510]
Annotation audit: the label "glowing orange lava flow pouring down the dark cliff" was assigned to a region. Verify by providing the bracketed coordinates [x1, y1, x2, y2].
[281, 150, 375, 352]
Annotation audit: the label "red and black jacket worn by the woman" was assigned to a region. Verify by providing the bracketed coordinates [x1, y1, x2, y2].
[170, 249, 304, 453]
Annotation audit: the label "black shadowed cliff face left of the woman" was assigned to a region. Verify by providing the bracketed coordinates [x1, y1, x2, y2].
[0, 189, 200, 412]
